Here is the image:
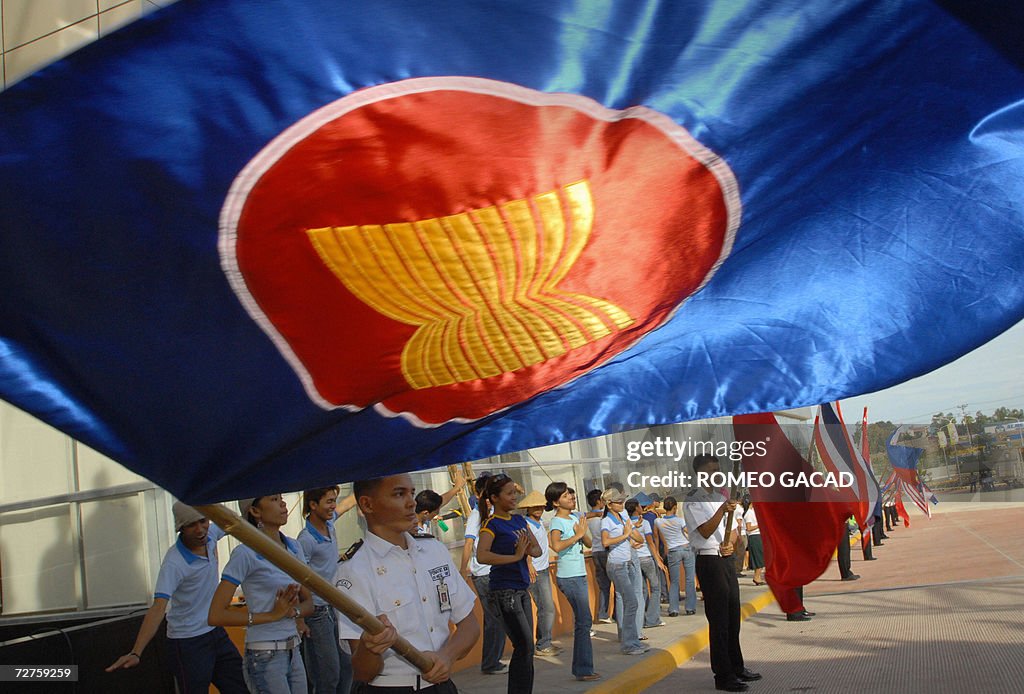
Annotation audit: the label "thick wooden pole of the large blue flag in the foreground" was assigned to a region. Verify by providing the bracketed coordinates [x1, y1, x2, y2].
[195, 504, 433, 673]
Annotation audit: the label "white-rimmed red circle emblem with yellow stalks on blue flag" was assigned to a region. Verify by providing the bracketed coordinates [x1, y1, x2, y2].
[221, 77, 739, 426]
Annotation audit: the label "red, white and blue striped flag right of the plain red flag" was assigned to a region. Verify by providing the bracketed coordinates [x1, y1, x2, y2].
[814, 402, 880, 535]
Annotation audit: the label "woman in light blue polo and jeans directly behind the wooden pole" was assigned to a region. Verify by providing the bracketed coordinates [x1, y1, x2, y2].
[208, 494, 313, 694]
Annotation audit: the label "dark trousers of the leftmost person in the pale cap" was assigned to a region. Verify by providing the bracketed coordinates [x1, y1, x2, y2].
[167, 626, 249, 694]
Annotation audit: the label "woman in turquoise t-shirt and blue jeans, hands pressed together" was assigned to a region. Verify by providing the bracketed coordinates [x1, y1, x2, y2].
[544, 482, 601, 682]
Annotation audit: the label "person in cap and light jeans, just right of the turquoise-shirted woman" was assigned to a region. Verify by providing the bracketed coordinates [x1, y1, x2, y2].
[601, 489, 650, 655]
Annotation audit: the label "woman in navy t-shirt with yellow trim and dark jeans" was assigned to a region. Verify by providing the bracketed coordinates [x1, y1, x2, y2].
[476, 475, 541, 694]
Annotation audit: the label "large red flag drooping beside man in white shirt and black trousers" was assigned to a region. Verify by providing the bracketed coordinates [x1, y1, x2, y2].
[732, 414, 854, 613]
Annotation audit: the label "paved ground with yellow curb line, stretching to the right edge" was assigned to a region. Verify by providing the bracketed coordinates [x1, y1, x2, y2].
[454, 503, 1024, 694]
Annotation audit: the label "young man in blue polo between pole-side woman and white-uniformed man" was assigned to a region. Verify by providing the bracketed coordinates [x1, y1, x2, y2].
[298, 486, 352, 694]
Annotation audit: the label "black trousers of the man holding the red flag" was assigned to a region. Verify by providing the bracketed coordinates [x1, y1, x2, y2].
[696, 554, 743, 683]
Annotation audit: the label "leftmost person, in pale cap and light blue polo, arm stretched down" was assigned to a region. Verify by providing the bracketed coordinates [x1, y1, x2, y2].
[106, 502, 248, 694]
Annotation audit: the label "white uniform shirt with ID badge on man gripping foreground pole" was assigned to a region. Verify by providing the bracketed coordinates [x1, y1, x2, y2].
[334, 532, 476, 686]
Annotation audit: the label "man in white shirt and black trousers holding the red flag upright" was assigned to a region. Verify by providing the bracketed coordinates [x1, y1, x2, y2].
[683, 453, 761, 692]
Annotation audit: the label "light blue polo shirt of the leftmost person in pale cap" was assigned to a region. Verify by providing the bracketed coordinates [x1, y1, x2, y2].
[154, 523, 224, 639]
